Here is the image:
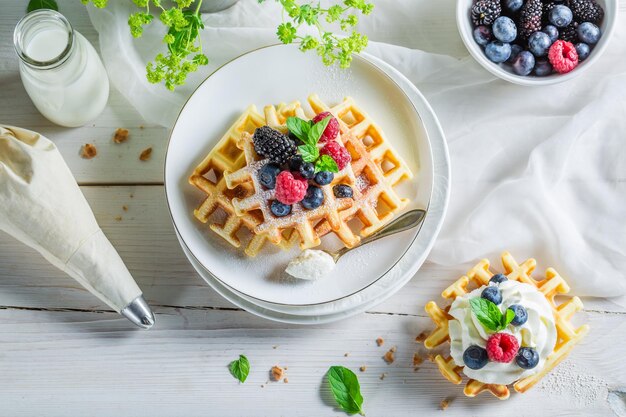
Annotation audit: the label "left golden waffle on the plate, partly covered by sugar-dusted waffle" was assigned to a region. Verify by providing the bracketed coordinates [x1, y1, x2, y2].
[189, 102, 304, 256]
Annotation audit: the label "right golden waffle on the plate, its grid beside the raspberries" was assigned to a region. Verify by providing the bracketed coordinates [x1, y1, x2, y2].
[308, 94, 413, 247]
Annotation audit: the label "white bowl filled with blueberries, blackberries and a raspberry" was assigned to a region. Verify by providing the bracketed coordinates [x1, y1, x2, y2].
[456, 0, 618, 85]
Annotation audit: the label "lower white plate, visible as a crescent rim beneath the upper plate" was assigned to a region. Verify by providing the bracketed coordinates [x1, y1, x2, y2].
[172, 50, 450, 324]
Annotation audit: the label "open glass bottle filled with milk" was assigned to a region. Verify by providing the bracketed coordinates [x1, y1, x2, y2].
[13, 10, 109, 127]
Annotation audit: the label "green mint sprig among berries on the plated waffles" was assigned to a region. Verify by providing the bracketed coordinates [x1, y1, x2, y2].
[287, 116, 339, 173]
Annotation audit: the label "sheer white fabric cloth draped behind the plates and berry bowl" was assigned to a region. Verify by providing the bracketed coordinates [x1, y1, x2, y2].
[89, 0, 626, 297]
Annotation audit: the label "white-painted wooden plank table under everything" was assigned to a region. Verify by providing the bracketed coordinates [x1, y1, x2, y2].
[0, 0, 626, 417]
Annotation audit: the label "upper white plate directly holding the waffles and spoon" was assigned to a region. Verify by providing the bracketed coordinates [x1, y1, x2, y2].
[165, 45, 433, 306]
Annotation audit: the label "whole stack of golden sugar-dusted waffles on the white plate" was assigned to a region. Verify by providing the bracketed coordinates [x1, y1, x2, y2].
[189, 94, 413, 257]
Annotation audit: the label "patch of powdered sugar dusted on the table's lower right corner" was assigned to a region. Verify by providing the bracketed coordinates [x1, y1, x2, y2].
[539, 360, 608, 407]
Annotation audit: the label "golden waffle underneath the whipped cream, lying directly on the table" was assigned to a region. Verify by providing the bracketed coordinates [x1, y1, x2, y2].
[424, 252, 589, 400]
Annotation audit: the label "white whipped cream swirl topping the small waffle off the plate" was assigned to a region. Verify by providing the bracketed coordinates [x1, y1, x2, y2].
[449, 281, 557, 385]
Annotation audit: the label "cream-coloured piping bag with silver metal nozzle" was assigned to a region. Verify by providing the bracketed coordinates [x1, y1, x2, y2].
[0, 125, 154, 329]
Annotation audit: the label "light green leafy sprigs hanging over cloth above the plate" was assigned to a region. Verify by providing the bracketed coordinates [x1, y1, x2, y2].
[77, 0, 374, 91]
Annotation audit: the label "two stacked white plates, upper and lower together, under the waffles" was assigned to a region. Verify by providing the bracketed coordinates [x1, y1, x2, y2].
[165, 45, 450, 324]
